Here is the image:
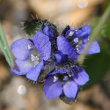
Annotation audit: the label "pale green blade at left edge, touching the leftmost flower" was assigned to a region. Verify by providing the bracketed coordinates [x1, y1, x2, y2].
[0, 24, 14, 67]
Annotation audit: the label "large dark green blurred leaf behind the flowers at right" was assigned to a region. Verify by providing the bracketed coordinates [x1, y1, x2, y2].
[83, 39, 110, 88]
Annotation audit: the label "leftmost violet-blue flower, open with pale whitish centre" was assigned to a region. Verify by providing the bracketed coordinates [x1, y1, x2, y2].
[11, 25, 51, 81]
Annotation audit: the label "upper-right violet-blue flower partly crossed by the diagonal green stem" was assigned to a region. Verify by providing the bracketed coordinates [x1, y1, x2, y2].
[57, 26, 100, 59]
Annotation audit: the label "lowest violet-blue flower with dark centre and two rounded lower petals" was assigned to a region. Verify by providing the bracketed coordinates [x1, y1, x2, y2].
[44, 65, 89, 99]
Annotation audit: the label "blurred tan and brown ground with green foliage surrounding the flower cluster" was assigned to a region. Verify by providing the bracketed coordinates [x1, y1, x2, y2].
[0, 0, 110, 110]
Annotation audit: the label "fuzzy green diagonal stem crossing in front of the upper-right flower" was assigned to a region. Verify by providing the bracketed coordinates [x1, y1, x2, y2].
[78, 3, 110, 64]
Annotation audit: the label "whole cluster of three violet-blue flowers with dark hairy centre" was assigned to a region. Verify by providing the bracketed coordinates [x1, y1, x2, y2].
[11, 23, 100, 103]
